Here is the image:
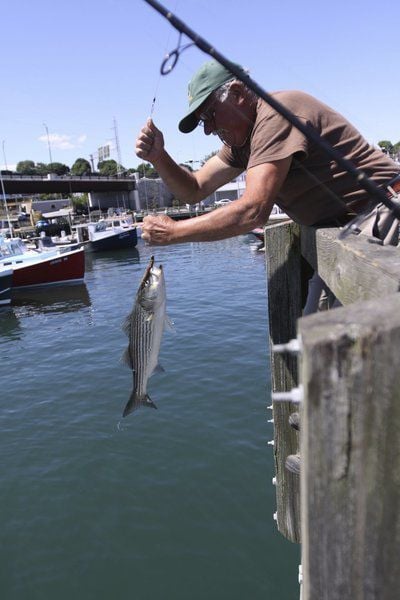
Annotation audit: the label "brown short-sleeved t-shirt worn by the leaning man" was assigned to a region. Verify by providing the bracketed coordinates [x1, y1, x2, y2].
[218, 91, 399, 225]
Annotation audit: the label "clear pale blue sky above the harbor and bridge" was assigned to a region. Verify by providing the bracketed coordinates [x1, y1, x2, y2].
[0, 0, 400, 168]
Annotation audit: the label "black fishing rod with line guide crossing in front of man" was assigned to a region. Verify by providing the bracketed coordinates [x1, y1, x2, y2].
[144, 0, 400, 223]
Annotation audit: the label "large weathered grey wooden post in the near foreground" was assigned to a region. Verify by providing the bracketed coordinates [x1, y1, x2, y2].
[299, 296, 400, 600]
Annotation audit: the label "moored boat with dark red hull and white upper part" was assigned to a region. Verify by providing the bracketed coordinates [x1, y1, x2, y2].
[0, 236, 85, 288]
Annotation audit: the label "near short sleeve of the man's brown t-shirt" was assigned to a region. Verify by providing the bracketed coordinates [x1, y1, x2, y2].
[247, 110, 308, 169]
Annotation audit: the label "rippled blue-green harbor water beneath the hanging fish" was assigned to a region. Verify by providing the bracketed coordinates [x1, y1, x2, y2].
[0, 236, 299, 600]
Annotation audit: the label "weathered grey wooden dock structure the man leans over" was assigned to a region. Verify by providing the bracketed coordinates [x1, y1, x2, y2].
[265, 222, 400, 600]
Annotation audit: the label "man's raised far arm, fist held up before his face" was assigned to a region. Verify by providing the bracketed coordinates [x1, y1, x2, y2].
[136, 119, 242, 204]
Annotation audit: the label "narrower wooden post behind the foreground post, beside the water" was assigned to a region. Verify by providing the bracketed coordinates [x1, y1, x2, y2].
[265, 221, 301, 542]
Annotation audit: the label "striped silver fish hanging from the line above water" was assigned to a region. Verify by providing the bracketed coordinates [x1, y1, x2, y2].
[123, 256, 167, 417]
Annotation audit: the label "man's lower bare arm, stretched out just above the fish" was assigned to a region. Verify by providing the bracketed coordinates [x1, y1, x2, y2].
[142, 157, 292, 245]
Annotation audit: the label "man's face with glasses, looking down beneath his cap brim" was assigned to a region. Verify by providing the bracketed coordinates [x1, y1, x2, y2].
[195, 90, 253, 147]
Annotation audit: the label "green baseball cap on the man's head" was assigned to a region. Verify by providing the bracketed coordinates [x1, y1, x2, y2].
[178, 60, 244, 133]
